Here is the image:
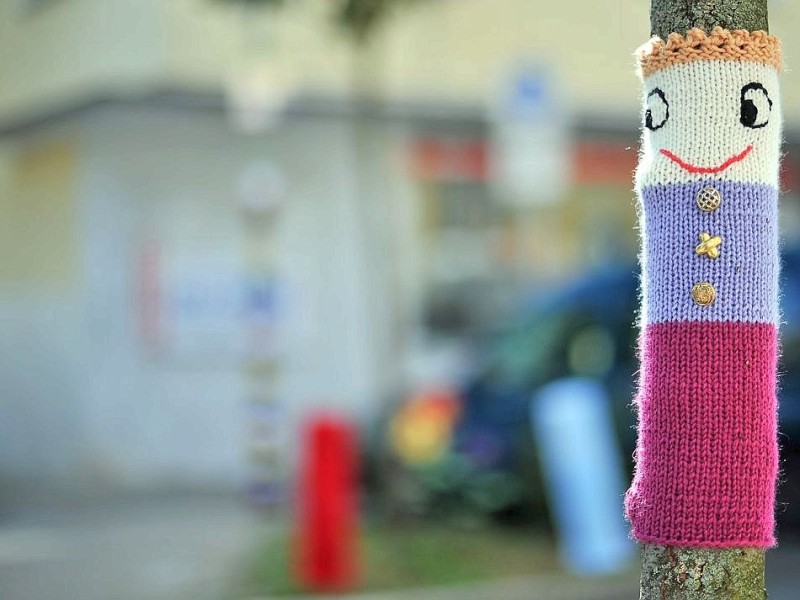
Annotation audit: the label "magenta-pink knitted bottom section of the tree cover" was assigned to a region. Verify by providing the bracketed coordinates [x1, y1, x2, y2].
[625, 322, 778, 548]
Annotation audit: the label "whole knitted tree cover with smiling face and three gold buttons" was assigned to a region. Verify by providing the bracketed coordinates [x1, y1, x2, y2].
[625, 28, 781, 548]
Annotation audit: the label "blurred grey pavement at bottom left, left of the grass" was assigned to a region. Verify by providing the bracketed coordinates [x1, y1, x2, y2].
[0, 496, 268, 600]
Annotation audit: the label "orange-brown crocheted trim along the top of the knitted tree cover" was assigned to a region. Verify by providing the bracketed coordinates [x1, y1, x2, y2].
[636, 27, 781, 77]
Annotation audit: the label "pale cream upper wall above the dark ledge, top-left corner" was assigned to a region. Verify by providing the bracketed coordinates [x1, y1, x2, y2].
[0, 0, 167, 122]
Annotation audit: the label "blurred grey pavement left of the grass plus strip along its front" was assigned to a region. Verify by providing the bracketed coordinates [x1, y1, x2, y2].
[0, 496, 800, 600]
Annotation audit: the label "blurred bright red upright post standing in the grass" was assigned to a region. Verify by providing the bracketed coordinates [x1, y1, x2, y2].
[294, 415, 360, 592]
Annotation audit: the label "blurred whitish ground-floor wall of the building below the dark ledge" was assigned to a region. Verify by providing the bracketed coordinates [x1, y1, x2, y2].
[0, 102, 412, 490]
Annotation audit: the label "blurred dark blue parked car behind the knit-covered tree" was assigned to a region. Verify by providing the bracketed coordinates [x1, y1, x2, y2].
[446, 248, 800, 531]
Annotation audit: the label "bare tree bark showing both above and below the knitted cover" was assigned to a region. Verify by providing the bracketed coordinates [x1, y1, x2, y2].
[640, 0, 768, 600]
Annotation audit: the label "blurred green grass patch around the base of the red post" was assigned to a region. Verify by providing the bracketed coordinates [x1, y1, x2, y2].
[243, 525, 558, 596]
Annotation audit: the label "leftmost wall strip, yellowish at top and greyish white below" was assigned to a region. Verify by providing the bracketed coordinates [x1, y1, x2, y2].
[0, 127, 86, 502]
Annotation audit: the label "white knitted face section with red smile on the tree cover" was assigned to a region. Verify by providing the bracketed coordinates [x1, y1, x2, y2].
[636, 60, 782, 189]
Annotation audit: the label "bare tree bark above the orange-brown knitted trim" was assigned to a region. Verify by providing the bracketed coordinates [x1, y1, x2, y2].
[650, 0, 769, 39]
